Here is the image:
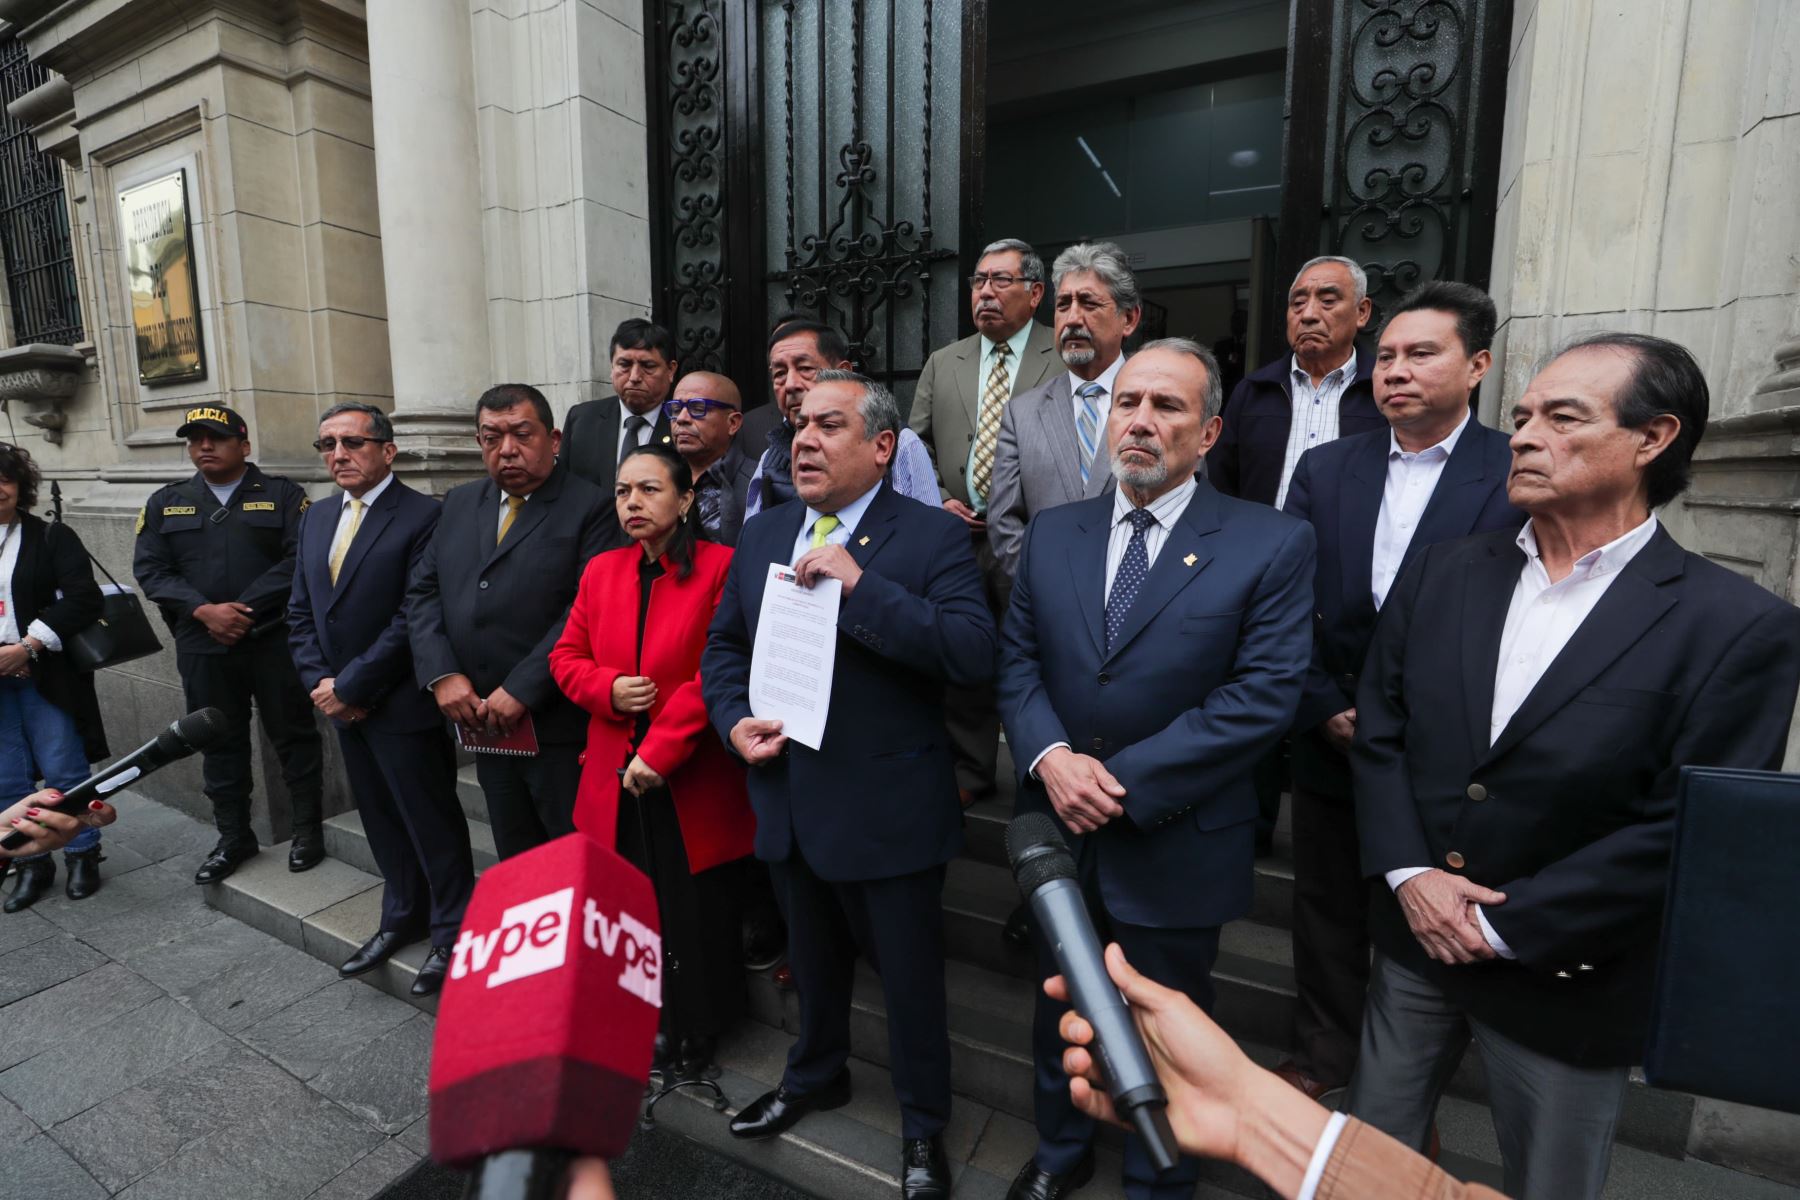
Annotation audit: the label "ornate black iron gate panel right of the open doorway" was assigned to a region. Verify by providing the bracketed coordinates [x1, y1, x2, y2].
[1276, 0, 1512, 320]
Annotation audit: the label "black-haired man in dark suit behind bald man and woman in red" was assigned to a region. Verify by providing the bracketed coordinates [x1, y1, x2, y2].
[560, 317, 680, 549]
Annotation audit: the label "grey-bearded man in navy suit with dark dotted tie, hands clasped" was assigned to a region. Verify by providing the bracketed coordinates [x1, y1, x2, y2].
[999, 338, 1314, 1200]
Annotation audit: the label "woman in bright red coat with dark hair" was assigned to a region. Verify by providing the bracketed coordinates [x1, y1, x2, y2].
[551, 444, 756, 1078]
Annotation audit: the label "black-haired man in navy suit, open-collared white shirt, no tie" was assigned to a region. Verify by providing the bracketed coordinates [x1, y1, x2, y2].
[1276, 281, 1525, 1099]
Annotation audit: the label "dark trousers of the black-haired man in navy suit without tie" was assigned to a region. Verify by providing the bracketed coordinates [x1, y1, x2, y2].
[1292, 786, 1370, 1085]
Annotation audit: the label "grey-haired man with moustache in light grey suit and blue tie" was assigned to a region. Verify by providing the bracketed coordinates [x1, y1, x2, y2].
[988, 241, 1143, 581]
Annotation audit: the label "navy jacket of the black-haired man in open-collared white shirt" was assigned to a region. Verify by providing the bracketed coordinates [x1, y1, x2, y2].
[1285, 417, 1525, 799]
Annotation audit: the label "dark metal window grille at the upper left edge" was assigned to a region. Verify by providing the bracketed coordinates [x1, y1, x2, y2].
[0, 38, 81, 345]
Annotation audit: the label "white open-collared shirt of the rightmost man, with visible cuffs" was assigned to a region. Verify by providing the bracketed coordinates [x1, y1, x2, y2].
[1388, 513, 1656, 959]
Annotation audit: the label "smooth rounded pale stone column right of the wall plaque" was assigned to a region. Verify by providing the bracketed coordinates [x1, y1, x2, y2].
[369, 0, 493, 491]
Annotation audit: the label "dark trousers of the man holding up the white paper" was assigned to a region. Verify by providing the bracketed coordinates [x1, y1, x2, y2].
[769, 846, 950, 1137]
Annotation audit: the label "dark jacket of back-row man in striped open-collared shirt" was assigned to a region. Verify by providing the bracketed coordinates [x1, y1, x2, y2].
[1206, 347, 1388, 504]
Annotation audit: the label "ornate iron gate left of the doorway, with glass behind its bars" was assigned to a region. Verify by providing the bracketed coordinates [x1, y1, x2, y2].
[646, 0, 986, 403]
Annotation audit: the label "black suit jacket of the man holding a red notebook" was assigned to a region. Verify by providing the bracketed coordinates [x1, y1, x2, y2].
[407, 464, 617, 743]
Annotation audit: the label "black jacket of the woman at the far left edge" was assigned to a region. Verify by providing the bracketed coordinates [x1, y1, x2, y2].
[0, 513, 110, 759]
